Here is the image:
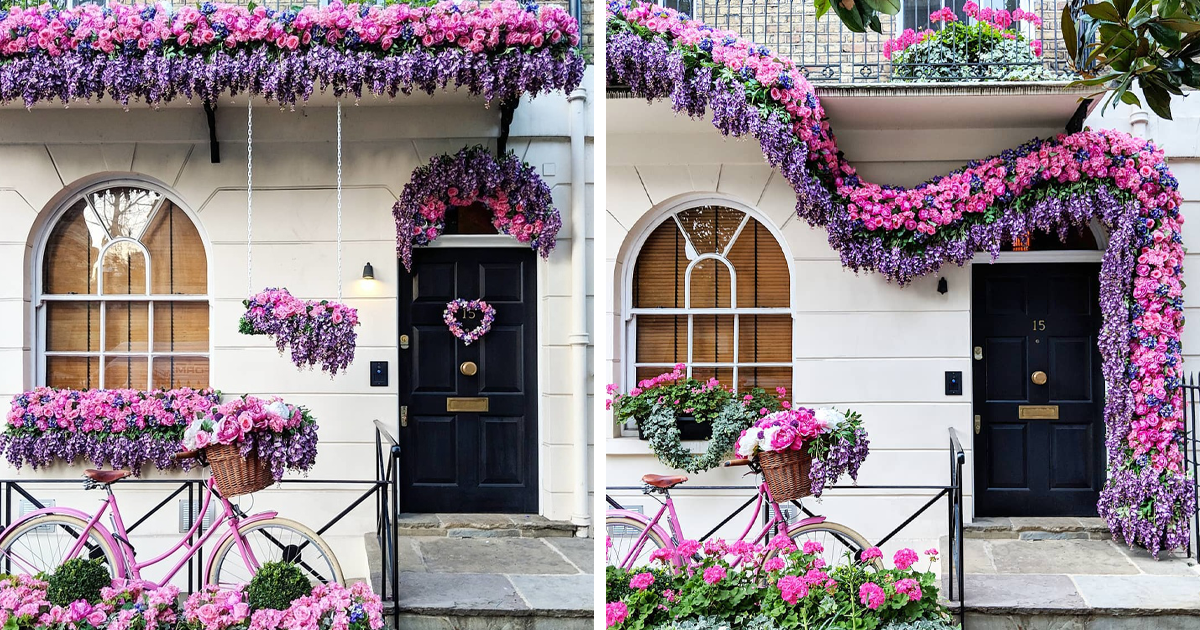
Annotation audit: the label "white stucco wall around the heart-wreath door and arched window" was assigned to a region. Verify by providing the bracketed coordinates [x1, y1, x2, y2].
[0, 71, 594, 585]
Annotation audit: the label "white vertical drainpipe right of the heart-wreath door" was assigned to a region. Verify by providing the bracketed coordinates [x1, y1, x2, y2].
[568, 83, 592, 533]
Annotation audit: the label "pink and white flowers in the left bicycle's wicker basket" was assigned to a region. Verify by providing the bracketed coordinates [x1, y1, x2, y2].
[182, 396, 317, 481]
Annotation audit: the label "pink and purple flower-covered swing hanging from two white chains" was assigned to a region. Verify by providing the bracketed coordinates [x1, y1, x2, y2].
[238, 288, 359, 377]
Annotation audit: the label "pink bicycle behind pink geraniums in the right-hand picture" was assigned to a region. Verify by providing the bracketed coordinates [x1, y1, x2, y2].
[605, 460, 882, 570]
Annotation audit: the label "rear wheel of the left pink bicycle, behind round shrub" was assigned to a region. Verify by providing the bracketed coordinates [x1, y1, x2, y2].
[0, 514, 120, 577]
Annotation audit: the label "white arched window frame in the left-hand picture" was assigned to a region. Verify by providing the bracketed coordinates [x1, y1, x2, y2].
[31, 179, 212, 391]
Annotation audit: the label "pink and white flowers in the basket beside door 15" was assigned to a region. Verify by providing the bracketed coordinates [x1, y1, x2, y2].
[734, 407, 870, 497]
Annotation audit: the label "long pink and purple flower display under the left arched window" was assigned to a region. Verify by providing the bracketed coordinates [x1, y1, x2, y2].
[0, 388, 221, 473]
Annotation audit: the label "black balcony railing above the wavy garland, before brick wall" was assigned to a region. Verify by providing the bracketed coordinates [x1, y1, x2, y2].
[659, 0, 1082, 84]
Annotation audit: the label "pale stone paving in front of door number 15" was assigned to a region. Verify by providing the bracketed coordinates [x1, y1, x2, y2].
[942, 518, 1200, 630]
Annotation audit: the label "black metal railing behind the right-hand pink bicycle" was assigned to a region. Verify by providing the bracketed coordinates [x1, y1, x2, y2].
[605, 427, 966, 614]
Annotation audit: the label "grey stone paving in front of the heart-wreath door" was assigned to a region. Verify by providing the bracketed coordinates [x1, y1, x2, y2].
[366, 534, 595, 630]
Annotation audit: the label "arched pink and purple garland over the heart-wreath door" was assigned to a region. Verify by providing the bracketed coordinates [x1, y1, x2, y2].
[391, 146, 563, 271]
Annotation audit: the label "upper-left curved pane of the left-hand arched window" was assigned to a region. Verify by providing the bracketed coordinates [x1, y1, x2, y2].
[42, 200, 108, 295]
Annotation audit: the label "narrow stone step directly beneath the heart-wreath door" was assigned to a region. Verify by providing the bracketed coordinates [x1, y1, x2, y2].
[396, 514, 578, 538]
